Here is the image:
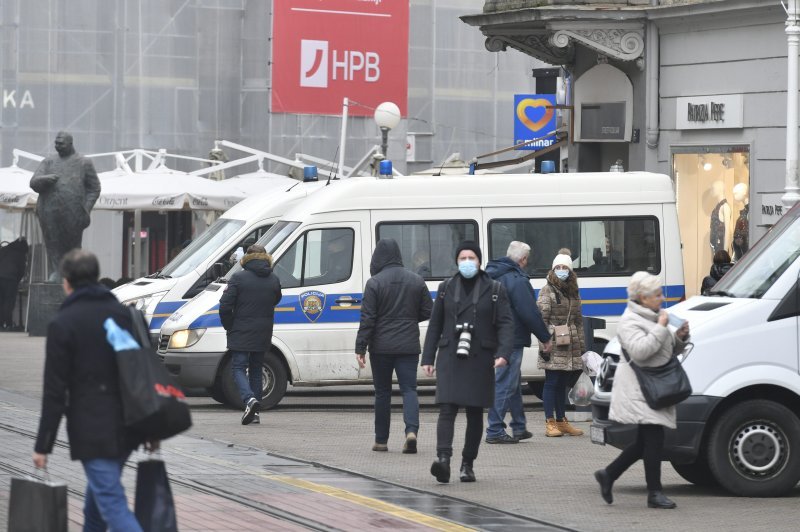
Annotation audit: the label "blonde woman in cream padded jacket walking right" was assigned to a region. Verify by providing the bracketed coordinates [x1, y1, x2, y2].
[594, 272, 689, 508]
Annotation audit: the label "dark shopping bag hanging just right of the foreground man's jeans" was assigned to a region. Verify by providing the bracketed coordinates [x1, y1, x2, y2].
[134, 460, 178, 532]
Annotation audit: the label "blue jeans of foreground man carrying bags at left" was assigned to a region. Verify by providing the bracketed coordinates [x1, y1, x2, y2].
[81, 455, 142, 532]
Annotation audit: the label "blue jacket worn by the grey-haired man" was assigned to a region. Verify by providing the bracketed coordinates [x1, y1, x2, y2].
[486, 257, 551, 349]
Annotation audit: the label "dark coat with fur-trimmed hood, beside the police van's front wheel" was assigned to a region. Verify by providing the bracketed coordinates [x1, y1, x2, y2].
[219, 253, 281, 352]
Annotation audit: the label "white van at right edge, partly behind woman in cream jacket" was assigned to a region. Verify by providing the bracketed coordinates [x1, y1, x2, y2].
[591, 206, 800, 497]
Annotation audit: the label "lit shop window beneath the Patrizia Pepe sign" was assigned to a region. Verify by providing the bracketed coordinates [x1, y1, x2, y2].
[672, 146, 750, 297]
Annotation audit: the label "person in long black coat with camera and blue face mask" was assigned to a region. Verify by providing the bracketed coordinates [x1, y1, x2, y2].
[422, 242, 514, 482]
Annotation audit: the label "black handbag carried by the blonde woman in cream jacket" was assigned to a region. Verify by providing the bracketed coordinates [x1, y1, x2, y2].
[622, 349, 692, 410]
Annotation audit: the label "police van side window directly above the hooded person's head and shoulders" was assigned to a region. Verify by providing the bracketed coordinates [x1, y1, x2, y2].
[375, 220, 478, 280]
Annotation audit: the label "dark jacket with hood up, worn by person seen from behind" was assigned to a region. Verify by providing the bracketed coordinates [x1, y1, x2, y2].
[355, 239, 433, 355]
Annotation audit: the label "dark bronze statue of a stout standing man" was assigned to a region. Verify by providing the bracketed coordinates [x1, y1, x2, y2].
[31, 131, 100, 281]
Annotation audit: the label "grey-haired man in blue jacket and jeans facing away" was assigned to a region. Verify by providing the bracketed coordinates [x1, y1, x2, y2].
[486, 240, 552, 443]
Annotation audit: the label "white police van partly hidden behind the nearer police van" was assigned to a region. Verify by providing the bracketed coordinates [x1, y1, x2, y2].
[113, 178, 324, 338]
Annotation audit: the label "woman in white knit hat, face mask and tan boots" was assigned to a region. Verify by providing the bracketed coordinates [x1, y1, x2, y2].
[537, 255, 586, 437]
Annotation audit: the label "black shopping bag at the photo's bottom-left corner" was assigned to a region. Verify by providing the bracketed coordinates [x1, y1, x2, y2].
[8, 477, 67, 532]
